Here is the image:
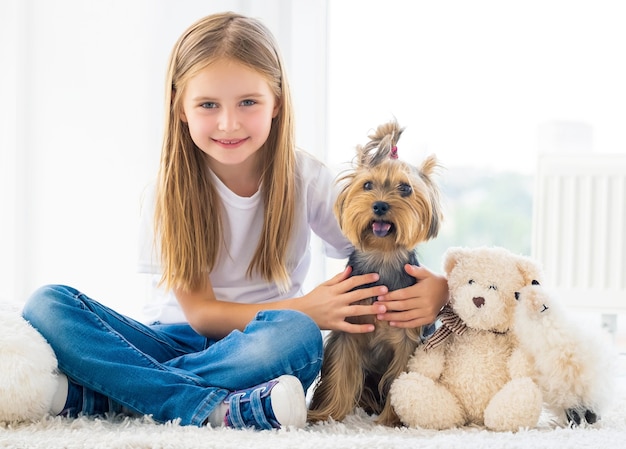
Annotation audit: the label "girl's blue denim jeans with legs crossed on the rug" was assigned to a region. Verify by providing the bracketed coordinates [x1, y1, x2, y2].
[23, 285, 322, 426]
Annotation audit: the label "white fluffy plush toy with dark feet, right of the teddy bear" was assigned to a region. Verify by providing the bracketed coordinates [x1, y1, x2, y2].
[513, 282, 615, 426]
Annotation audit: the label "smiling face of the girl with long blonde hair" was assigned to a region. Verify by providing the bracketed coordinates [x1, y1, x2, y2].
[181, 59, 279, 172]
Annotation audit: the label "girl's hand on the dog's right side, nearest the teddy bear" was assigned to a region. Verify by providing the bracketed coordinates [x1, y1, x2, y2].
[376, 264, 449, 328]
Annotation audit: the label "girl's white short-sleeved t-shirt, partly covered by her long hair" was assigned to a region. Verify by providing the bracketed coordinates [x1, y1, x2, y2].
[139, 151, 352, 323]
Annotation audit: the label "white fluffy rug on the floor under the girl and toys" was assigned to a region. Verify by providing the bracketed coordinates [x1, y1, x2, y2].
[0, 378, 626, 449]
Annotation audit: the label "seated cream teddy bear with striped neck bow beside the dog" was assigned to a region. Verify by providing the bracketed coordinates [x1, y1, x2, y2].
[390, 247, 542, 431]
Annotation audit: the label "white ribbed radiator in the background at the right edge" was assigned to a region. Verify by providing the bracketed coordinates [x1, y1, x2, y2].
[532, 153, 626, 314]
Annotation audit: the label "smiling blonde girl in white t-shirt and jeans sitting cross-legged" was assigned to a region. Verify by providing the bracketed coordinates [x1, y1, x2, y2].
[23, 13, 448, 429]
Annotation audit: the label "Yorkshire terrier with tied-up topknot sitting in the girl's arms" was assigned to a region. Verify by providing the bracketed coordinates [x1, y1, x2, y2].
[309, 121, 442, 426]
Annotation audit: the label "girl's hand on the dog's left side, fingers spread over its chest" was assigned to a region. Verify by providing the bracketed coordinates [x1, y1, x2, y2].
[298, 267, 388, 333]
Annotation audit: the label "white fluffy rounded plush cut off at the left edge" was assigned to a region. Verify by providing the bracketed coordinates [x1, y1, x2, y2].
[0, 305, 58, 422]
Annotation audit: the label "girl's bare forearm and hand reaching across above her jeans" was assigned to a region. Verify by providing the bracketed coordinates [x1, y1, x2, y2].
[174, 268, 387, 338]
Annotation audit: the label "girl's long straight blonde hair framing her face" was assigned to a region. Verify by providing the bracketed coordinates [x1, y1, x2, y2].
[154, 12, 296, 291]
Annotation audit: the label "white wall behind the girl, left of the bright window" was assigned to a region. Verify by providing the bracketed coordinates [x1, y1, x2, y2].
[0, 0, 326, 315]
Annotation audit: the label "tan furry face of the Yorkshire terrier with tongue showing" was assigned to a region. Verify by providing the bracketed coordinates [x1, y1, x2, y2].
[335, 156, 441, 252]
